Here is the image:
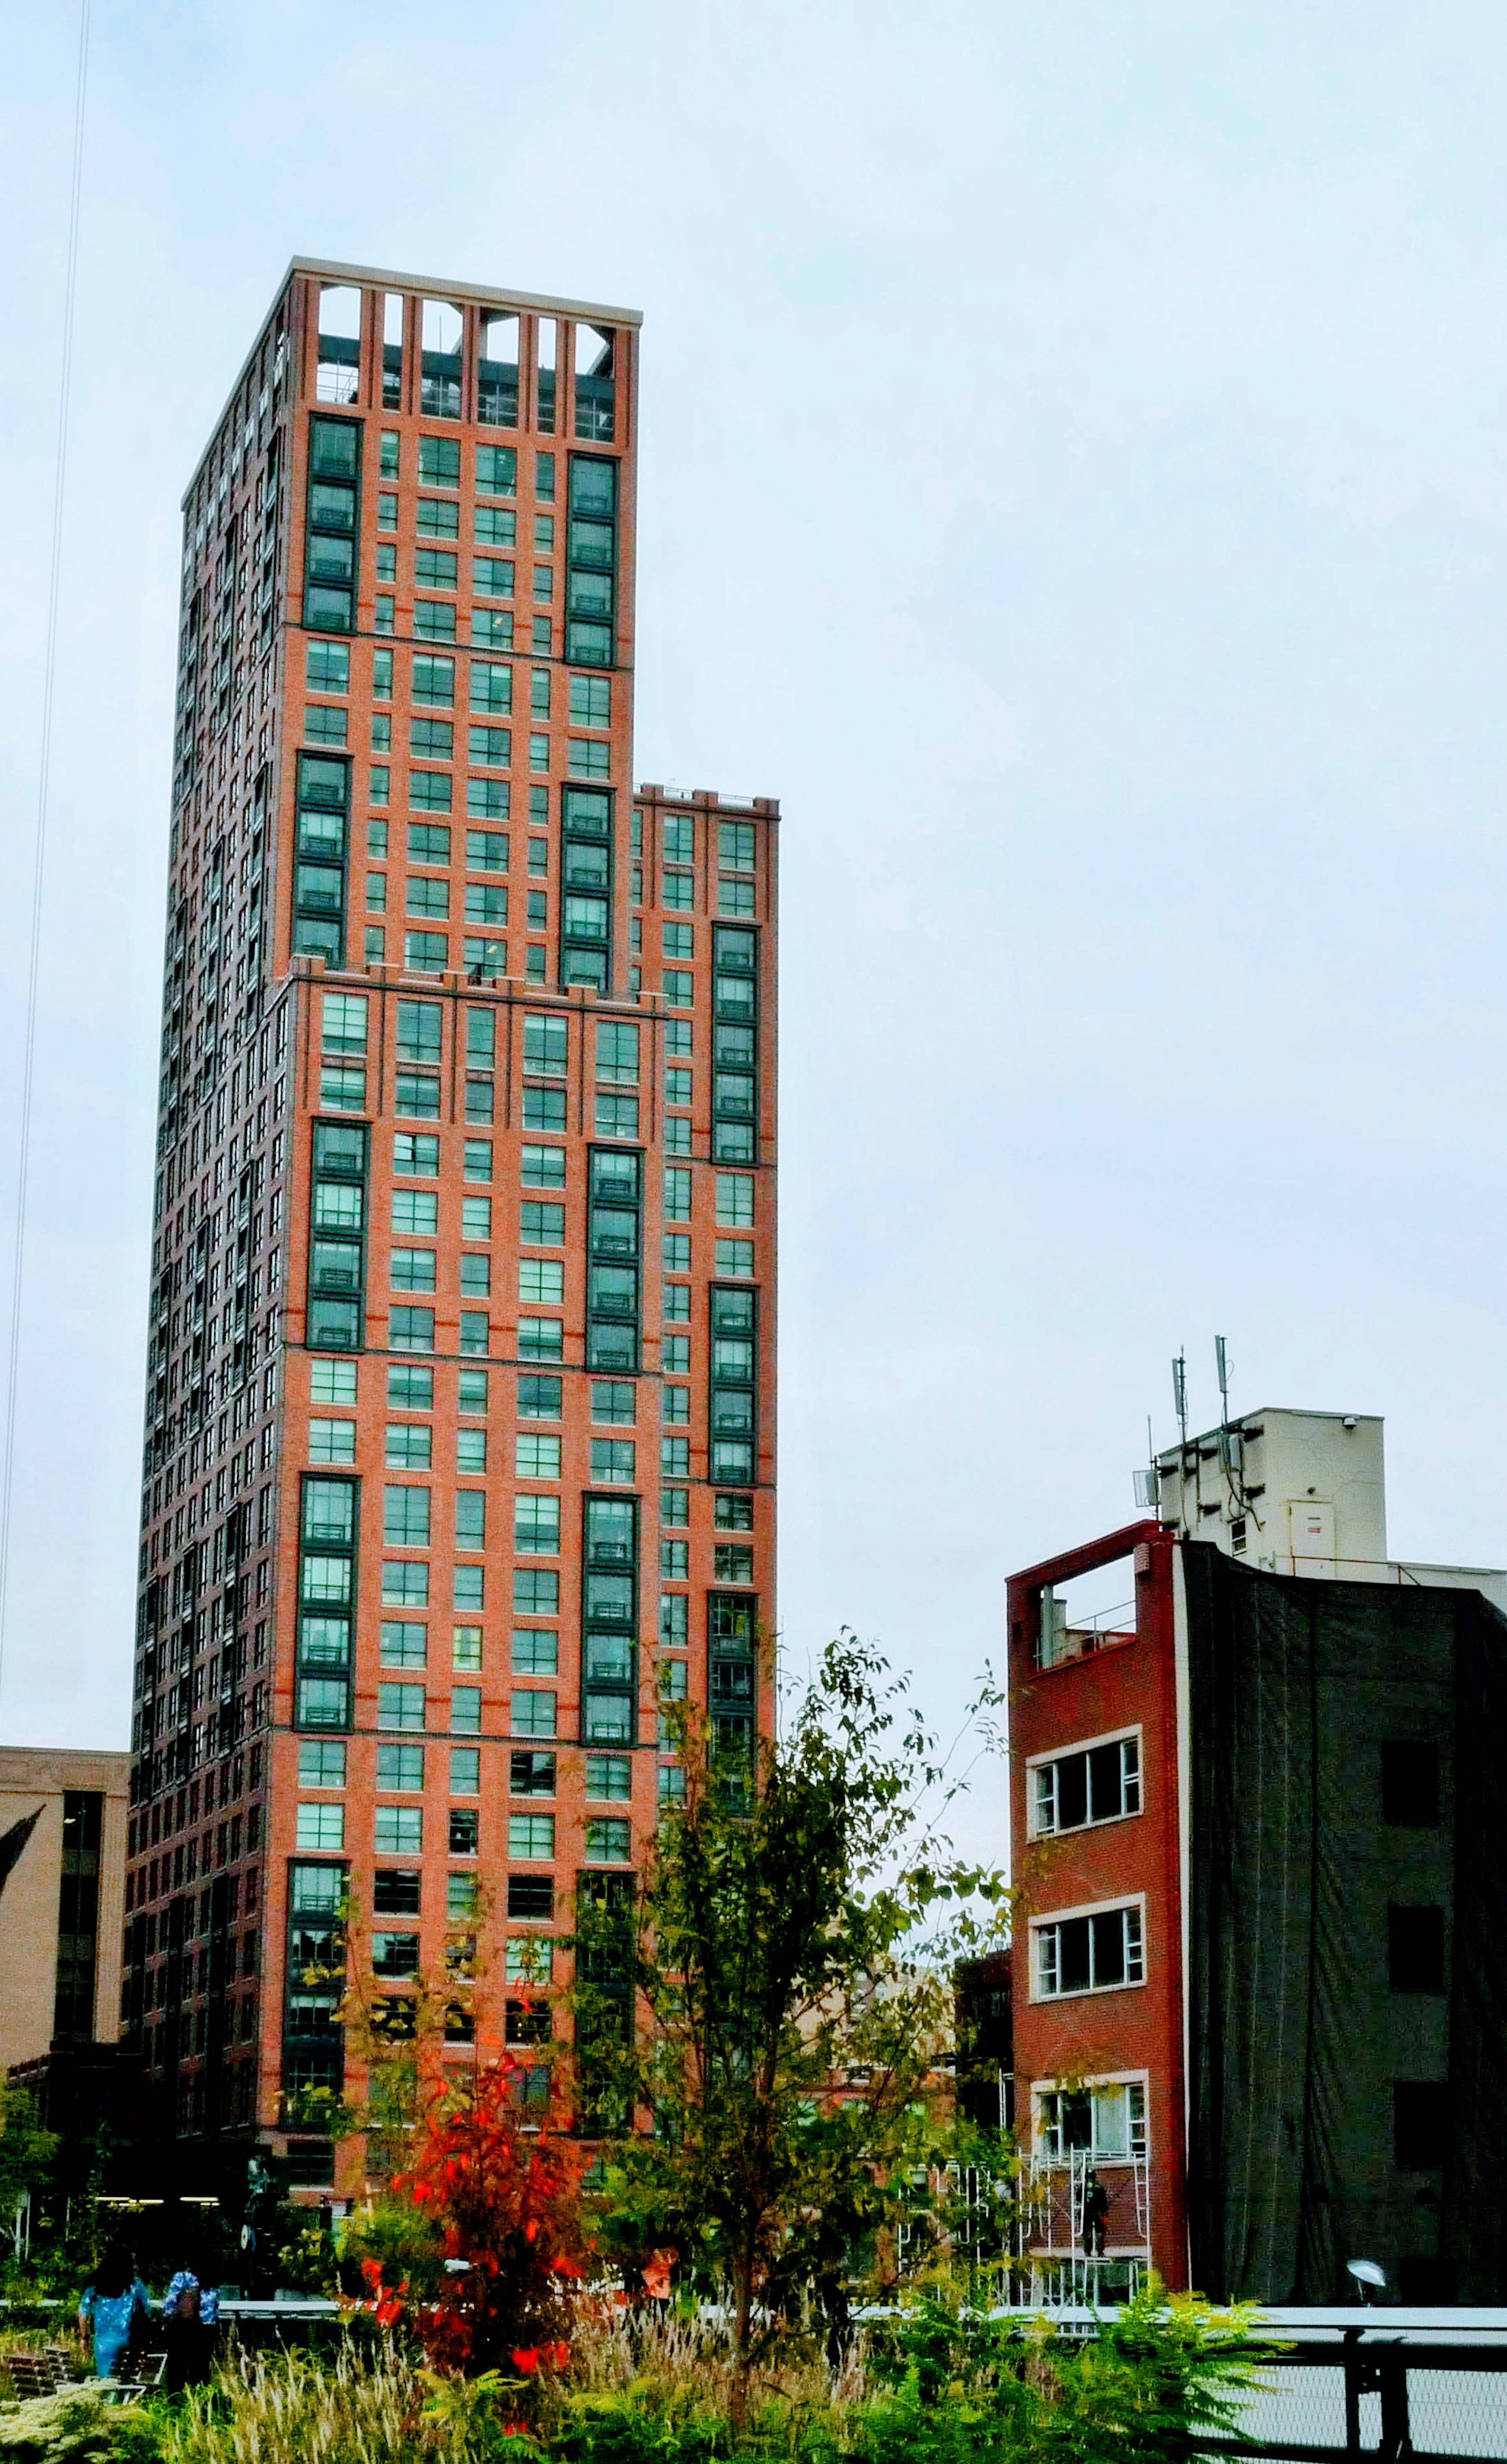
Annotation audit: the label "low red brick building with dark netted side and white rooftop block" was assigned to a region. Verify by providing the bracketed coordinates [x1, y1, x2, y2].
[1009, 1412, 1507, 2304]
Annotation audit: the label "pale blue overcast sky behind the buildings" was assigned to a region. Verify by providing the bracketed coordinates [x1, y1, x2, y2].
[0, 0, 1507, 1853]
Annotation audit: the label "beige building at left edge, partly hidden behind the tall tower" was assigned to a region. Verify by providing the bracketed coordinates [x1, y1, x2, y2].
[0, 1744, 131, 2077]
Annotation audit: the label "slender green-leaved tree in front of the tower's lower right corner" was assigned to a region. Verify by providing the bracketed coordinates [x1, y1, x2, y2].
[572, 1634, 1004, 2422]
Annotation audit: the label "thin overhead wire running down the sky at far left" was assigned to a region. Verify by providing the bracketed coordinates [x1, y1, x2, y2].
[0, 0, 91, 1715]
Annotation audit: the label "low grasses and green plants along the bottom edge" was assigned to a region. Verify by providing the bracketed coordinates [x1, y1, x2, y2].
[0, 2284, 1270, 2464]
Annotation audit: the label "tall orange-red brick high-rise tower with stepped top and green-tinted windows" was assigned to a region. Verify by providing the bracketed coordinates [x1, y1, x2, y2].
[123, 259, 777, 2188]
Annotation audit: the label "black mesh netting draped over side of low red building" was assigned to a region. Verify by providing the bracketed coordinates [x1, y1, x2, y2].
[1181, 1542, 1507, 2302]
